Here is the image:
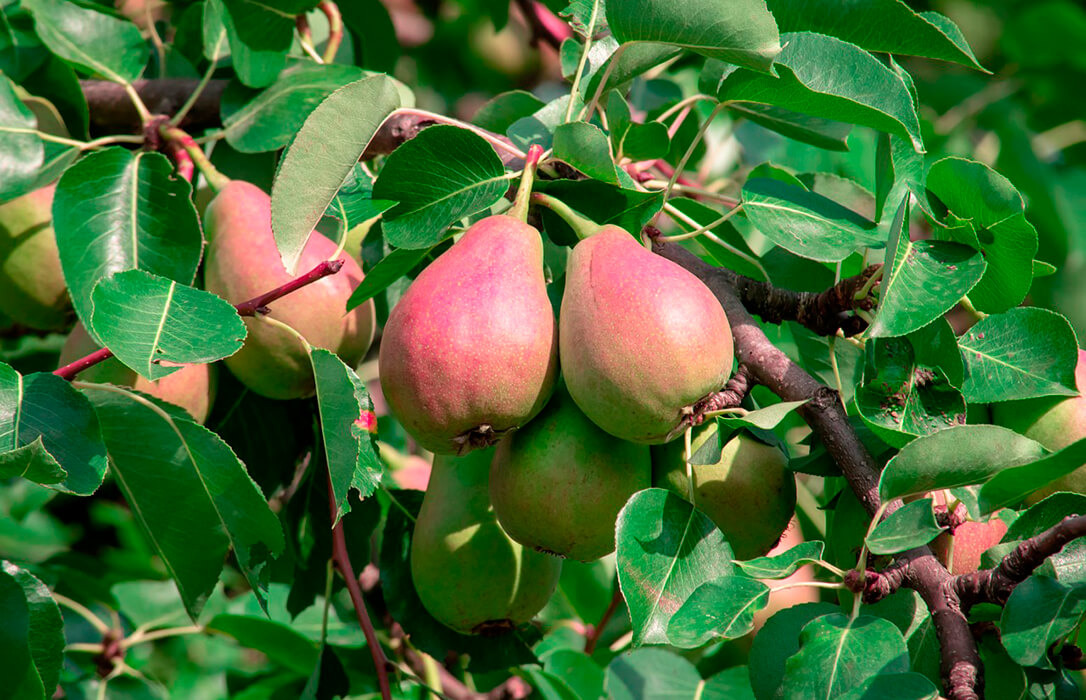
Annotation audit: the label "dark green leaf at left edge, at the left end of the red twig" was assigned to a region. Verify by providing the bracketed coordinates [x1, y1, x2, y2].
[0, 362, 106, 496]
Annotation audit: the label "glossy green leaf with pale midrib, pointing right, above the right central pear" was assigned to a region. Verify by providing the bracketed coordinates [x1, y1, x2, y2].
[743, 178, 883, 263]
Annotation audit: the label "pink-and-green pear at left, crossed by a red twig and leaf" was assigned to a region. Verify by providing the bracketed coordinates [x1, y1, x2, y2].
[204, 180, 377, 398]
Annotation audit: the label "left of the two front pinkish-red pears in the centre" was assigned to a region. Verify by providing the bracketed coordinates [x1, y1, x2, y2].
[379, 215, 558, 455]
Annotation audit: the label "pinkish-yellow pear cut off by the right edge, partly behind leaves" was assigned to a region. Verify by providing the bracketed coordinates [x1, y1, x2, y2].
[992, 349, 1086, 505]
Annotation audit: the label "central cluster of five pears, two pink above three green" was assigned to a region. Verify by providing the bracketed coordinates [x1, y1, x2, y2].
[379, 154, 795, 633]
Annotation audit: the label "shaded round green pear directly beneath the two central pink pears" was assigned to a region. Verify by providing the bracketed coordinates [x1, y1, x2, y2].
[490, 382, 653, 561]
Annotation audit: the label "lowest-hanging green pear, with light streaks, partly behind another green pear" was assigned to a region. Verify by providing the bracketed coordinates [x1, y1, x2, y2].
[411, 449, 561, 634]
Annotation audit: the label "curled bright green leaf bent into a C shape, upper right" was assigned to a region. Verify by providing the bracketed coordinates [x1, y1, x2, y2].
[925, 157, 1037, 314]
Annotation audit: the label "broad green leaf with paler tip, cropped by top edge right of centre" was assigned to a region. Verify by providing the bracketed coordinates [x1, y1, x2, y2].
[607, 0, 781, 71]
